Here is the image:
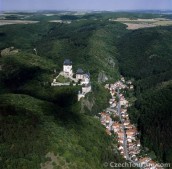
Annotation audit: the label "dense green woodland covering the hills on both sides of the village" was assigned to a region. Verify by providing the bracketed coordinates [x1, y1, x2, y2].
[0, 12, 172, 169]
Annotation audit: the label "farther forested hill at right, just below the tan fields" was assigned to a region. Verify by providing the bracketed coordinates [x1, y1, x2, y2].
[119, 27, 172, 81]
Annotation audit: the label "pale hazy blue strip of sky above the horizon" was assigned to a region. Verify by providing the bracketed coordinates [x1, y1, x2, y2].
[0, 0, 172, 11]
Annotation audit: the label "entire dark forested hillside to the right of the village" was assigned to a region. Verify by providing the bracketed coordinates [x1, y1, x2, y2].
[118, 27, 172, 162]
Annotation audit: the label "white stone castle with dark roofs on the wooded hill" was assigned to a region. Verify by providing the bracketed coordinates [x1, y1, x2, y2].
[51, 59, 91, 101]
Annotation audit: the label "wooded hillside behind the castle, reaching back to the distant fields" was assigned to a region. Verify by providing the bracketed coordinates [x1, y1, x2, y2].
[0, 15, 126, 114]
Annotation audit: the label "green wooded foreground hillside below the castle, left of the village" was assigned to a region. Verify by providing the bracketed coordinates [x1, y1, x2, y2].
[0, 94, 119, 169]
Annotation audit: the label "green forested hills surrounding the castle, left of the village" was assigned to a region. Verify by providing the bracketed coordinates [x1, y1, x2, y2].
[0, 12, 130, 169]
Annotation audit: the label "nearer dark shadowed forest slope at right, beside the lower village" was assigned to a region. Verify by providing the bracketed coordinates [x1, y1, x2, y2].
[136, 82, 172, 162]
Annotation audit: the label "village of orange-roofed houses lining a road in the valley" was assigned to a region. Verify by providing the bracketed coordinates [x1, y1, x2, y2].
[99, 77, 162, 169]
